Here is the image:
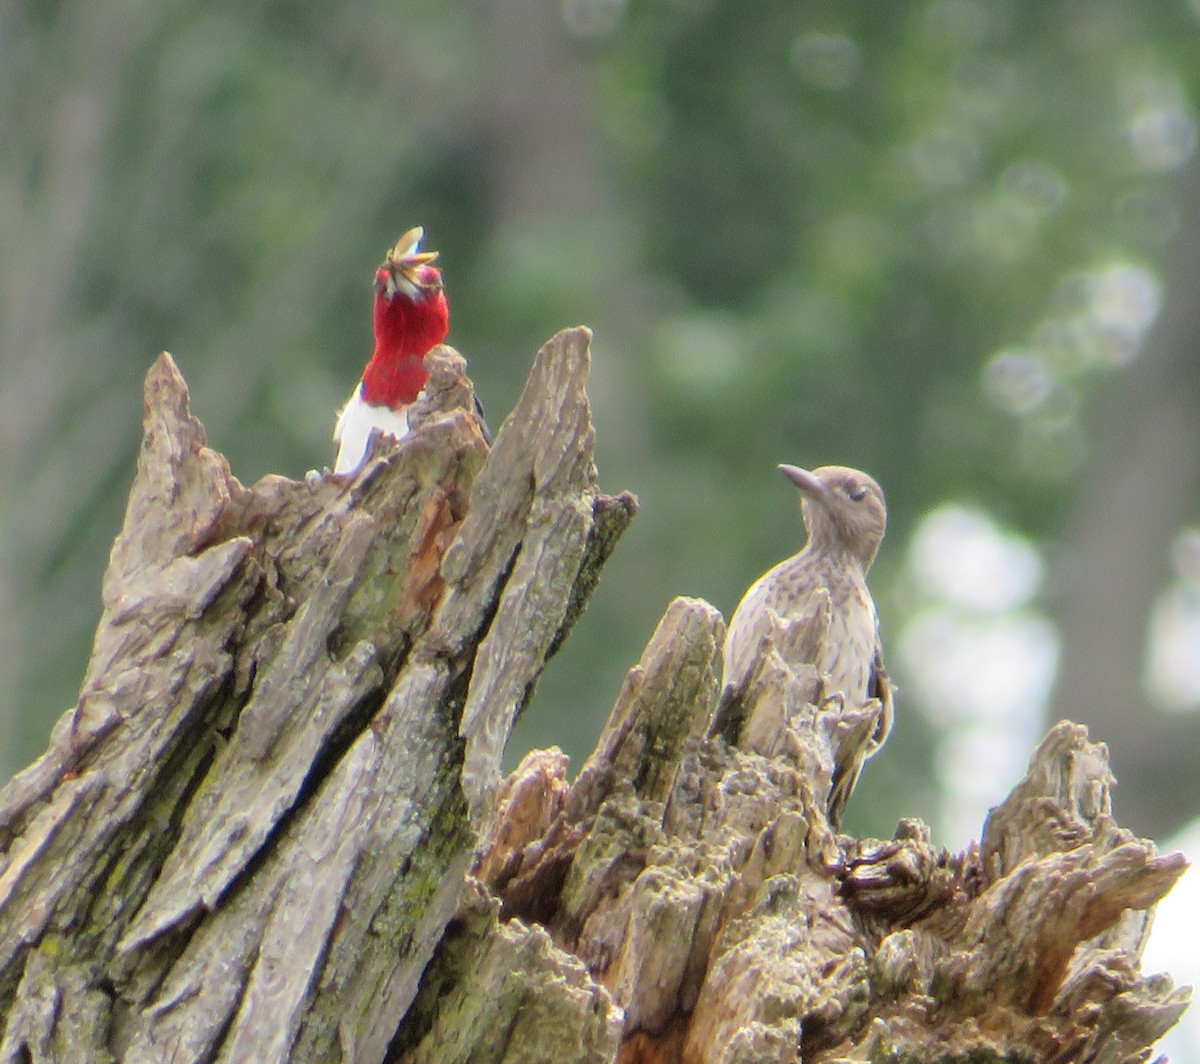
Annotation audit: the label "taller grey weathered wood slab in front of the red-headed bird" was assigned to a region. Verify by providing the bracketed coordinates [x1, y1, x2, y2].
[0, 329, 634, 1062]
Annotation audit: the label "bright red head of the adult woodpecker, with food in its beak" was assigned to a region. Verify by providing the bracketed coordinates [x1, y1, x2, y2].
[362, 226, 450, 409]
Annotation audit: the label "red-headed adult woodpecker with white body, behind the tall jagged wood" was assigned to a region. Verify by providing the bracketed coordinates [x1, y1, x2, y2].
[334, 226, 450, 473]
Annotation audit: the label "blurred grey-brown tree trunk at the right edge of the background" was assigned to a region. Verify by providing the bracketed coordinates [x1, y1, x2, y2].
[1055, 162, 1200, 835]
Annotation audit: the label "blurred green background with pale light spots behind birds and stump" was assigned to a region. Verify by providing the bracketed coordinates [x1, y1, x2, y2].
[0, 0, 1200, 1062]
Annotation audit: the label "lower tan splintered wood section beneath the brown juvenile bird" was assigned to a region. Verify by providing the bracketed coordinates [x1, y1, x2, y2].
[456, 600, 1189, 1064]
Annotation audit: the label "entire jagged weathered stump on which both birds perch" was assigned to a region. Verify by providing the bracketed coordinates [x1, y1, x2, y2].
[0, 329, 1188, 1064]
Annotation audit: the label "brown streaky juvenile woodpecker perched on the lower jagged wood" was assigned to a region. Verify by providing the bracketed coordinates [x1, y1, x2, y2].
[724, 465, 892, 826]
